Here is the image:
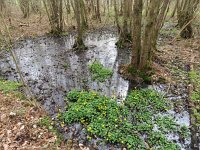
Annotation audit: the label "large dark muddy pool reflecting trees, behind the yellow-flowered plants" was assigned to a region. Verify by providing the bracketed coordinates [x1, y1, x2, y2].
[0, 34, 129, 113]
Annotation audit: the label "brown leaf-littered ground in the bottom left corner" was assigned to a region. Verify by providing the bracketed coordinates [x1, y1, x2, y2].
[0, 91, 67, 150]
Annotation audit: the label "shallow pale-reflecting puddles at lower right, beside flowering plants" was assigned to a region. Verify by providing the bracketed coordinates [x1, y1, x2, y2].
[148, 84, 191, 150]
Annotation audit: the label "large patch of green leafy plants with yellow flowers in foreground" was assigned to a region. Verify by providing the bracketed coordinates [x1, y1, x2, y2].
[59, 89, 189, 150]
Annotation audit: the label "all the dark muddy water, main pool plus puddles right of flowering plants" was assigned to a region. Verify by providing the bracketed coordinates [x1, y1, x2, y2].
[0, 32, 190, 149]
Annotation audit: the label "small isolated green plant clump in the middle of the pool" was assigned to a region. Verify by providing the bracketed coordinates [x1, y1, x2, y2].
[89, 61, 113, 82]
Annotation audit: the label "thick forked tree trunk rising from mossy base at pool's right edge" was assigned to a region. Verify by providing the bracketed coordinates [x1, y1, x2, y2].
[131, 0, 169, 71]
